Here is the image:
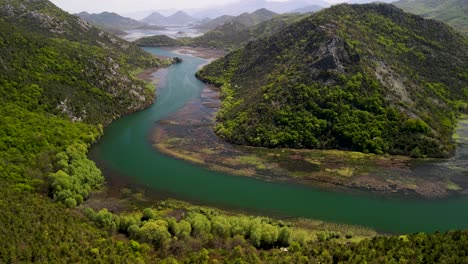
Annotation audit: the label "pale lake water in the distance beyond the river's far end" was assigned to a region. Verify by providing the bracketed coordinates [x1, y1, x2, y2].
[123, 26, 202, 41]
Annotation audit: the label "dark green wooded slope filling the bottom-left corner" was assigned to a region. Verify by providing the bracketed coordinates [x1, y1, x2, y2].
[0, 187, 147, 263]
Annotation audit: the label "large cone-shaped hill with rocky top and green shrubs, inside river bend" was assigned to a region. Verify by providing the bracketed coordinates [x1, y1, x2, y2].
[197, 4, 468, 157]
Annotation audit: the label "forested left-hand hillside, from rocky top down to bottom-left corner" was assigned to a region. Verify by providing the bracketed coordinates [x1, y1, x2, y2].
[0, 0, 166, 263]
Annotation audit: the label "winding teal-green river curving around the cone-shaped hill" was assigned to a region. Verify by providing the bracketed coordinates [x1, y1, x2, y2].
[92, 48, 468, 233]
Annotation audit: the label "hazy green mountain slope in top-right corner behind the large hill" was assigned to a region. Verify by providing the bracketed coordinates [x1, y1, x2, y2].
[393, 0, 468, 36]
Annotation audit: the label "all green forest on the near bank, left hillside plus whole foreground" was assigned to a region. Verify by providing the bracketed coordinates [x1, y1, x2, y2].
[0, 0, 468, 263]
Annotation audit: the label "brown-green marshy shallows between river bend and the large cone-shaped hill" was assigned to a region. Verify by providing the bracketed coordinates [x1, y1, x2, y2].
[151, 48, 468, 198]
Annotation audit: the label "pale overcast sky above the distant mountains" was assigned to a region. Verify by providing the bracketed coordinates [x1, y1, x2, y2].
[51, 0, 336, 13]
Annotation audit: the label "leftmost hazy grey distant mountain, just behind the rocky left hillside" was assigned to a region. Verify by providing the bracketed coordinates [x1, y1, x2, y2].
[77, 12, 163, 35]
